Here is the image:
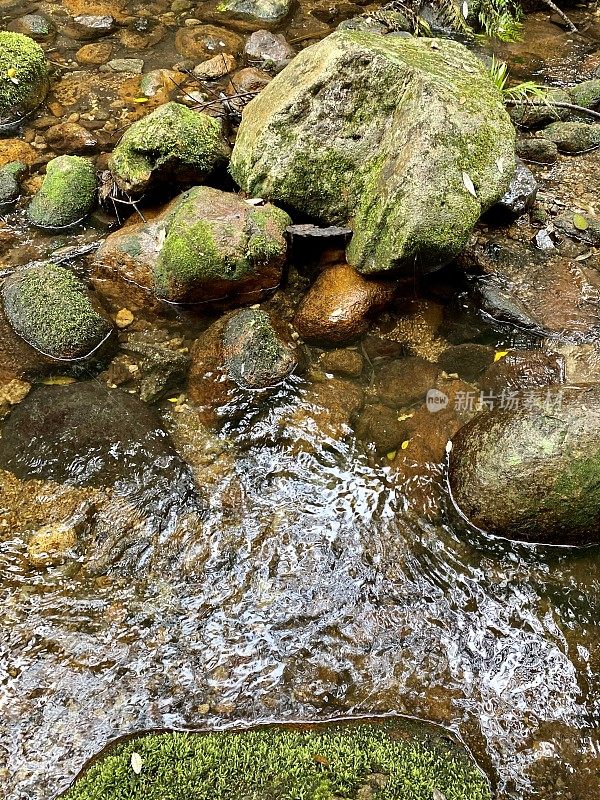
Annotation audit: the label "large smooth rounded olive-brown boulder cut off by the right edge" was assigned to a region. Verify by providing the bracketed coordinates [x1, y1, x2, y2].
[449, 386, 600, 545]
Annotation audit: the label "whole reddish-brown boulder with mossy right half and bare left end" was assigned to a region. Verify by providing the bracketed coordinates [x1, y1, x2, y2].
[94, 186, 290, 303]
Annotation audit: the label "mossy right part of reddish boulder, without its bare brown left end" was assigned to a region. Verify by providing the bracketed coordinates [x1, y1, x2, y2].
[154, 186, 290, 302]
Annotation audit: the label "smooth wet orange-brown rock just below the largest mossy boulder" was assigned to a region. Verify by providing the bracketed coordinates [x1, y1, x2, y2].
[294, 264, 395, 344]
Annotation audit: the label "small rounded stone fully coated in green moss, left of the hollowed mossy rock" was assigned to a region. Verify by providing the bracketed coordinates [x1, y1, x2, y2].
[27, 156, 96, 228]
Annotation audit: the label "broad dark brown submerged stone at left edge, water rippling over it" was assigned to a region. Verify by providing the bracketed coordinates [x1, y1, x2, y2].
[0, 381, 197, 499]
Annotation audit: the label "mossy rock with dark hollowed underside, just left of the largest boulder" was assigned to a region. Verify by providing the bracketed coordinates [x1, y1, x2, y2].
[109, 103, 229, 194]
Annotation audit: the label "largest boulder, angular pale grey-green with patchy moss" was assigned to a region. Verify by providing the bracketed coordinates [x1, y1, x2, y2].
[231, 30, 515, 275]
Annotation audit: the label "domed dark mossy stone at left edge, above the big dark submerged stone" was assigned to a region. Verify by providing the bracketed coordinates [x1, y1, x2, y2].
[2, 264, 112, 359]
